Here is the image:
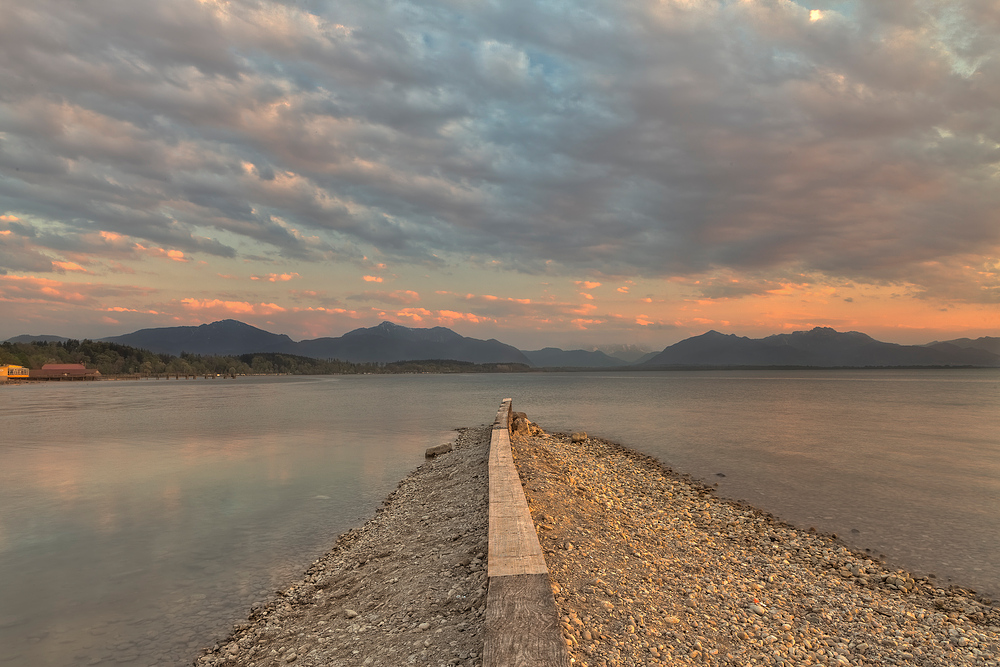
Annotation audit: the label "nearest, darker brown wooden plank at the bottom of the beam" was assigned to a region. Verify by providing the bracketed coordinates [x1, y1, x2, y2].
[483, 574, 569, 667]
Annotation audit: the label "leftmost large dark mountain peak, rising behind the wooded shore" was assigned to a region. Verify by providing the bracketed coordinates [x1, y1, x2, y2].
[101, 320, 300, 356]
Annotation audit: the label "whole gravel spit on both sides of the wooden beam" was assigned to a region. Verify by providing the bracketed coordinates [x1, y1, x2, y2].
[194, 415, 1000, 667]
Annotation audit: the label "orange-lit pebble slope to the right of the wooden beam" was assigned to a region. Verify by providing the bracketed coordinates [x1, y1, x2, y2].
[512, 426, 1000, 667]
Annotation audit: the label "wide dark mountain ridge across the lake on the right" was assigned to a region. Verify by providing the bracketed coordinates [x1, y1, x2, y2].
[642, 327, 1000, 368]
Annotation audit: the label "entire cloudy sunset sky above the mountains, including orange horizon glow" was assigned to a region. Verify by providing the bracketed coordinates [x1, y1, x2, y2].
[0, 0, 1000, 350]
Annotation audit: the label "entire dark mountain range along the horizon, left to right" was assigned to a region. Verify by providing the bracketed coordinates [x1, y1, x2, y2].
[3, 320, 1000, 370]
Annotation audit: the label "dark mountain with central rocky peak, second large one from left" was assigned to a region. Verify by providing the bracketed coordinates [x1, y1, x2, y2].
[296, 322, 531, 365]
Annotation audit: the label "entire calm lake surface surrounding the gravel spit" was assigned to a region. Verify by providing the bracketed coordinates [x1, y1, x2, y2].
[0, 371, 1000, 667]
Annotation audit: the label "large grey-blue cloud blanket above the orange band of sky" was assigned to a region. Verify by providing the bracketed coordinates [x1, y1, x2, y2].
[0, 0, 1000, 308]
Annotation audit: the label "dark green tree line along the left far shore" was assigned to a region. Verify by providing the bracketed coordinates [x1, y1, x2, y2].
[0, 340, 529, 375]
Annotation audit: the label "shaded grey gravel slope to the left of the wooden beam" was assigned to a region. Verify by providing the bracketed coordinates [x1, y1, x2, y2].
[194, 427, 490, 667]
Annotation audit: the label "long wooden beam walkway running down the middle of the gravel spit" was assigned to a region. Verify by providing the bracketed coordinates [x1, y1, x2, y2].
[483, 398, 570, 667]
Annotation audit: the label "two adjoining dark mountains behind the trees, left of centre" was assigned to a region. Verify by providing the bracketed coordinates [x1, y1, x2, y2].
[103, 320, 531, 365]
